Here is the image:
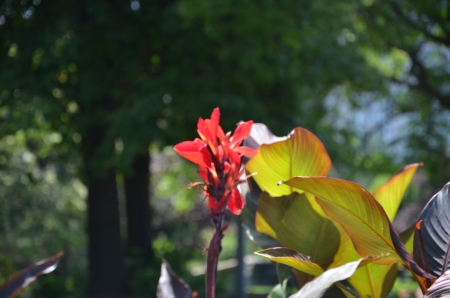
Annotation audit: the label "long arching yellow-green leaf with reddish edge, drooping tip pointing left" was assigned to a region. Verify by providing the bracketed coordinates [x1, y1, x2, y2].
[284, 177, 432, 278]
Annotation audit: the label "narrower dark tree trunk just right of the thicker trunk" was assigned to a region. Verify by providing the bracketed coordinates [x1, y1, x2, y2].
[124, 148, 152, 256]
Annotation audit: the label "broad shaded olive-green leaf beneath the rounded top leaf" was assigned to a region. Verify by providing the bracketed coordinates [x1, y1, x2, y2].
[256, 193, 344, 268]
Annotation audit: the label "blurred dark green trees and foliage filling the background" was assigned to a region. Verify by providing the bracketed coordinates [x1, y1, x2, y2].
[0, 0, 450, 297]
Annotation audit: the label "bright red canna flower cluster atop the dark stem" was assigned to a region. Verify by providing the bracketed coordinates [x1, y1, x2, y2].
[174, 108, 256, 215]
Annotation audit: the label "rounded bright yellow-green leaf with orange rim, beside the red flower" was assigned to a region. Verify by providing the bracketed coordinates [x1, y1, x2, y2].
[245, 127, 331, 196]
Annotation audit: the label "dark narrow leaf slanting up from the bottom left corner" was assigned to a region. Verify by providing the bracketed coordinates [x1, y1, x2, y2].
[0, 252, 64, 298]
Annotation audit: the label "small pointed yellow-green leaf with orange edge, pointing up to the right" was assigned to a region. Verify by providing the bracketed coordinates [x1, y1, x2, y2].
[373, 163, 422, 221]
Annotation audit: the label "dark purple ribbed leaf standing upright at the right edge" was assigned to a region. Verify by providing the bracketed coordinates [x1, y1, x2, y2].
[414, 183, 450, 277]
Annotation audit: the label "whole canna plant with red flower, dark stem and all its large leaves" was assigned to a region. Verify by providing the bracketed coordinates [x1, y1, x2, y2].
[162, 108, 450, 298]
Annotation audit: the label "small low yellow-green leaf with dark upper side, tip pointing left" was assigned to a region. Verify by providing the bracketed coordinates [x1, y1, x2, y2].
[255, 247, 324, 276]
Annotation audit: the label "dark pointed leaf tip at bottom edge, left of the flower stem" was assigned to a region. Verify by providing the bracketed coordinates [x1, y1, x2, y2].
[156, 260, 193, 298]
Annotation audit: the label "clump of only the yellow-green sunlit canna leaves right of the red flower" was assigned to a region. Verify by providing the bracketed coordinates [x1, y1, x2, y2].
[246, 123, 446, 297]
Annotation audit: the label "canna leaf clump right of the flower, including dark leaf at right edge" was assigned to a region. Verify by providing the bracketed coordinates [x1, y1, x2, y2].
[246, 124, 450, 297]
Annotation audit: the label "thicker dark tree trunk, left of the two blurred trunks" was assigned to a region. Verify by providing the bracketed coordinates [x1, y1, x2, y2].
[83, 128, 126, 298]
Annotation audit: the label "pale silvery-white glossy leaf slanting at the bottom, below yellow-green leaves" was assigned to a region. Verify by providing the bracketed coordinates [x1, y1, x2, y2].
[290, 259, 362, 298]
